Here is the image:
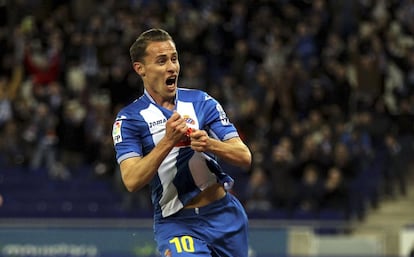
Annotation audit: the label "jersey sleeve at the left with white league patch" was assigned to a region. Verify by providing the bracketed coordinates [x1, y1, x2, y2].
[112, 116, 143, 163]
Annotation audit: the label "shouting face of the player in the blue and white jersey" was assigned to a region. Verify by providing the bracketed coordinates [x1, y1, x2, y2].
[134, 41, 180, 105]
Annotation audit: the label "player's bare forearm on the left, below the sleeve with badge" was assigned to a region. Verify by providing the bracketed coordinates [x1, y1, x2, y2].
[120, 137, 173, 192]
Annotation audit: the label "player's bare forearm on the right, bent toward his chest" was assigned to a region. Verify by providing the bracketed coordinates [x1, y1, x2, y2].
[209, 138, 252, 169]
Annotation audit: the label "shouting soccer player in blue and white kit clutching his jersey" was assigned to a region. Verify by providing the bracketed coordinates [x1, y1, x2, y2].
[112, 29, 252, 257]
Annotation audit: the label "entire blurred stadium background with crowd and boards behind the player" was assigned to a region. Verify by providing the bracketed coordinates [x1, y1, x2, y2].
[0, 0, 414, 257]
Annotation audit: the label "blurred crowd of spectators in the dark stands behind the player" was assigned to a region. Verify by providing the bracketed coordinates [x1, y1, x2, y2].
[0, 0, 414, 218]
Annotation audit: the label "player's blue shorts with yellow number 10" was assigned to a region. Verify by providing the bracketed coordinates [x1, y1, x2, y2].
[154, 193, 248, 257]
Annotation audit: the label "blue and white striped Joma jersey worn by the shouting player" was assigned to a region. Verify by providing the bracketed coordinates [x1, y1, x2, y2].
[112, 88, 239, 219]
